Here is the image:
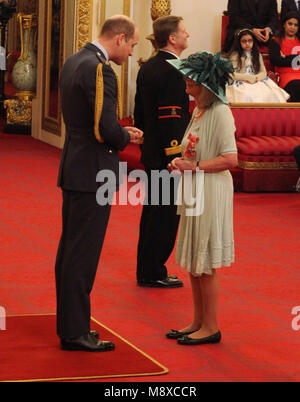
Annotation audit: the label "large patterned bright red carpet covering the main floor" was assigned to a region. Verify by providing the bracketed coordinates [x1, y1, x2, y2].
[0, 135, 300, 382]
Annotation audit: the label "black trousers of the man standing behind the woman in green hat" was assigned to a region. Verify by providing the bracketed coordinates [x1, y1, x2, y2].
[137, 169, 180, 282]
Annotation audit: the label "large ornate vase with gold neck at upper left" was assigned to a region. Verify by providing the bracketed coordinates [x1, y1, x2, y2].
[12, 13, 37, 100]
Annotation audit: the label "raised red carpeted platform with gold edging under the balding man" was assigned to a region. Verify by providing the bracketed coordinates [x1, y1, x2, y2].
[0, 315, 167, 382]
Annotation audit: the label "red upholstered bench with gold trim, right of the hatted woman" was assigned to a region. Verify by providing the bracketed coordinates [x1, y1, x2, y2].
[231, 103, 300, 192]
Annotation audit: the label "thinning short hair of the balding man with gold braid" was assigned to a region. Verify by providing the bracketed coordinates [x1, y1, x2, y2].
[100, 15, 136, 41]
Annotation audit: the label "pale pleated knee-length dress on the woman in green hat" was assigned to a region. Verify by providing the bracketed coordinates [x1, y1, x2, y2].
[176, 101, 237, 276]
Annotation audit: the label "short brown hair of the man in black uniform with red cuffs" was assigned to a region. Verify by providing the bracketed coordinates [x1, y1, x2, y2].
[153, 15, 183, 49]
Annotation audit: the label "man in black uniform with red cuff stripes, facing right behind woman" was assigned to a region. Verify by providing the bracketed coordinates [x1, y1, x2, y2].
[134, 16, 190, 288]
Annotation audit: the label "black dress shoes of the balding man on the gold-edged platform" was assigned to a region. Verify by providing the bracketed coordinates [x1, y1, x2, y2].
[61, 333, 115, 352]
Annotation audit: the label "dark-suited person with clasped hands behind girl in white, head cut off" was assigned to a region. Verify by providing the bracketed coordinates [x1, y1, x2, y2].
[223, 0, 278, 52]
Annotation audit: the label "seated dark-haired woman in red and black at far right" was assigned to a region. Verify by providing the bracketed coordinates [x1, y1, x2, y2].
[269, 11, 300, 102]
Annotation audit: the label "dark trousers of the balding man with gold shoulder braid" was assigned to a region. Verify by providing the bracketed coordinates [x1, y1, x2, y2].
[55, 190, 111, 339]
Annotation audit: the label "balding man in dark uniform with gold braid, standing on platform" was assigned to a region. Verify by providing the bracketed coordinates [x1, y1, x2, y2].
[55, 16, 142, 351]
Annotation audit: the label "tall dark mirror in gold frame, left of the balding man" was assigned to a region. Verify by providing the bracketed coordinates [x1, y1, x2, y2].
[42, 0, 65, 136]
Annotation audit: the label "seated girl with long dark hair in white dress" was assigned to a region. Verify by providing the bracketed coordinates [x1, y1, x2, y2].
[226, 29, 289, 103]
